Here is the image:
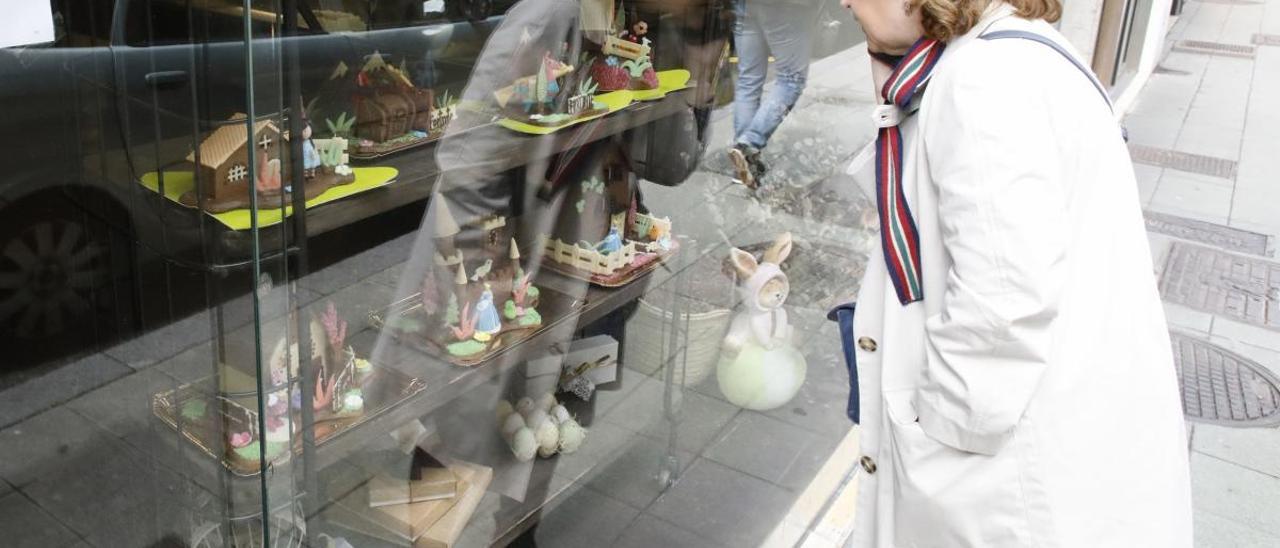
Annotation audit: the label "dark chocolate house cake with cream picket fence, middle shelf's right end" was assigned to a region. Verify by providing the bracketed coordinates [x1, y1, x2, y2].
[543, 150, 677, 287]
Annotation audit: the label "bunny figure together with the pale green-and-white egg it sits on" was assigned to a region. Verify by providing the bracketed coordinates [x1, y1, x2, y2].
[716, 233, 808, 411]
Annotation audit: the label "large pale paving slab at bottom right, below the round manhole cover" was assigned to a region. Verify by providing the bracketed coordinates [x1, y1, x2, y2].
[1192, 452, 1280, 535]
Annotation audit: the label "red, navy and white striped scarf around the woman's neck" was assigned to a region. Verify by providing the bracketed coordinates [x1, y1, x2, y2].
[874, 38, 946, 305]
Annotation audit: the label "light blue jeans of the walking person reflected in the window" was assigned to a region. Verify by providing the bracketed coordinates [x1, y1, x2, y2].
[733, 0, 818, 149]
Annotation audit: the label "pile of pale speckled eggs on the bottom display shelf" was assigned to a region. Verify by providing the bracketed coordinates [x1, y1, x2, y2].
[497, 393, 586, 462]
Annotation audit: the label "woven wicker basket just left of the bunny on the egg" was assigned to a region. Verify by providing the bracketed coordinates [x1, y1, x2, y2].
[623, 298, 732, 387]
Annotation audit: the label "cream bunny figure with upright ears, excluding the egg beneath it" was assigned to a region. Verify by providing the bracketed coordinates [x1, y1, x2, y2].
[724, 233, 791, 351]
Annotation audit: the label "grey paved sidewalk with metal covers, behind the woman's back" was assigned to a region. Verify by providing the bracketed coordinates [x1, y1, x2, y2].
[1125, 0, 1280, 547]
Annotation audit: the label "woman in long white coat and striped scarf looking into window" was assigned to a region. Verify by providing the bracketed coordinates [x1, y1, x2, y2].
[844, 0, 1192, 548]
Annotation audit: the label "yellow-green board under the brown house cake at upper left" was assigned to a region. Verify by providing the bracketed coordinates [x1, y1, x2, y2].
[141, 166, 399, 230]
